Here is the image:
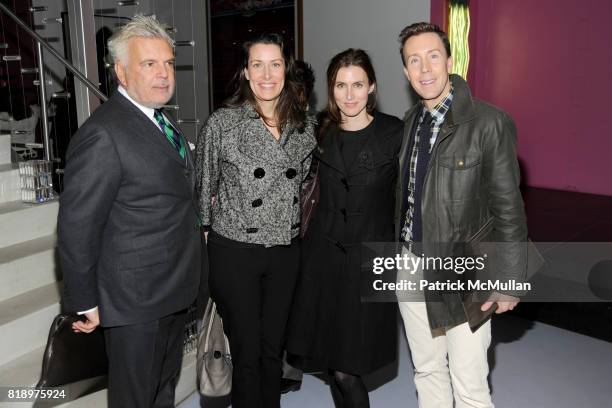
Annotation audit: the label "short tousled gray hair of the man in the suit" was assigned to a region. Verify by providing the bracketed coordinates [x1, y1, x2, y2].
[108, 14, 174, 64]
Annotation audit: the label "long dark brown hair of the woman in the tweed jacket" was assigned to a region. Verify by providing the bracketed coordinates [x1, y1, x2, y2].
[223, 33, 306, 132]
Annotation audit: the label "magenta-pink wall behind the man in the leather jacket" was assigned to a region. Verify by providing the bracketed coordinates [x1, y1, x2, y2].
[431, 0, 612, 195]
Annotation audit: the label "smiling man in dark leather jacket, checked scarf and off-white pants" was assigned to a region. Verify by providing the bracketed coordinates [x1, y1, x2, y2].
[396, 23, 527, 408]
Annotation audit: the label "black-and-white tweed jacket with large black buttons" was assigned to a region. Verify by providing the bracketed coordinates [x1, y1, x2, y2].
[196, 103, 316, 247]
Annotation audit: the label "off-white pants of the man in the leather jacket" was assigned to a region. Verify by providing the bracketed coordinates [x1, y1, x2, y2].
[399, 249, 493, 408]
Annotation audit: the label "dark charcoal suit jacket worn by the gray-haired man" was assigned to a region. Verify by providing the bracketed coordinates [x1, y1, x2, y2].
[58, 92, 202, 326]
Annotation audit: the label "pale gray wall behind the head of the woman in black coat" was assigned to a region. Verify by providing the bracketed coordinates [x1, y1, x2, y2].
[303, 0, 430, 118]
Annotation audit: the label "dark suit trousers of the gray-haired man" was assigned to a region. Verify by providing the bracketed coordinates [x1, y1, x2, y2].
[104, 310, 187, 408]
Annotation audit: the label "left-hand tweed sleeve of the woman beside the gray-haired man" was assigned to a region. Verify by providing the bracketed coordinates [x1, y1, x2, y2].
[196, 113, 221, 227]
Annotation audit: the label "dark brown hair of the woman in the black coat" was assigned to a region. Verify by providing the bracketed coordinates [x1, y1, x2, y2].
[320, 48, 376, 131]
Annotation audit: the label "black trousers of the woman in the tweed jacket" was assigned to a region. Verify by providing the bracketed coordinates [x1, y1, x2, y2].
[208, 235, 300, 408]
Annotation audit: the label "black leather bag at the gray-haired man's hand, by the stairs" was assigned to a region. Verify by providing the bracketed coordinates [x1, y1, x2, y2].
[36, 314, 108, 387]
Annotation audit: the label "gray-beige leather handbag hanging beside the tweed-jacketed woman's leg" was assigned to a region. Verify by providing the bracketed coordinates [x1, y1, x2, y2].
[196, 299, 232, 397]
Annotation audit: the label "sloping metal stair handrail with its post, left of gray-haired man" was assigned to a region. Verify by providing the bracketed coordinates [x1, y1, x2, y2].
[0, 3, 108, 160]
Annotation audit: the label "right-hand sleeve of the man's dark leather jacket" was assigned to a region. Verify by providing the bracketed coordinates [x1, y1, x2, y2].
[484, 113, 527, 296]
